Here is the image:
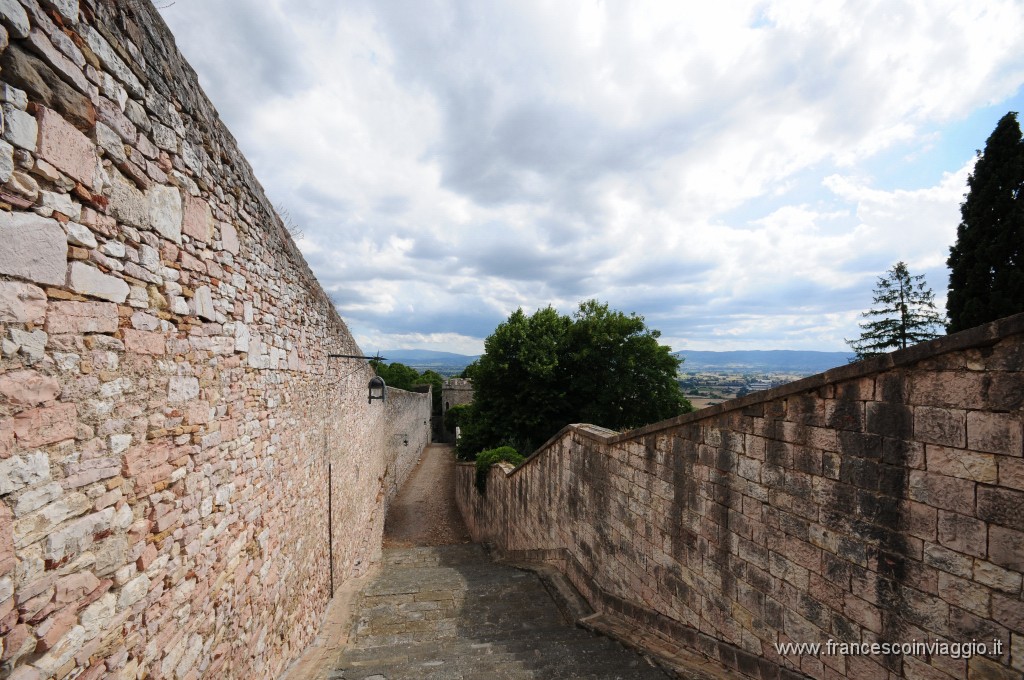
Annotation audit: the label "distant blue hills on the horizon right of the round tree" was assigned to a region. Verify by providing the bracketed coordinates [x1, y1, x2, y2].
[676, 349, 853, 375]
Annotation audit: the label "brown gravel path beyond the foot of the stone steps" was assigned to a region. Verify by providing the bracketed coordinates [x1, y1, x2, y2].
[384, 443, 470, 548]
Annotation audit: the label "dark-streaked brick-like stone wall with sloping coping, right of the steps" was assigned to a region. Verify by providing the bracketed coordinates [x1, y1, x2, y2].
[457, 314, 1024, 680]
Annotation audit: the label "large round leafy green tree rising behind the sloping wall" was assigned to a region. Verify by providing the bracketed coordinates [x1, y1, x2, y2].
[459, 300, 692, 458]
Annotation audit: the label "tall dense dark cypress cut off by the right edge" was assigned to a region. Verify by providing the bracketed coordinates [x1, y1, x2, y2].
[946, 112, 1024, 333]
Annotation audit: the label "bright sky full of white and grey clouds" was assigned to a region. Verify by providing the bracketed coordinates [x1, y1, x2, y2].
[157, 0, 1024, 354]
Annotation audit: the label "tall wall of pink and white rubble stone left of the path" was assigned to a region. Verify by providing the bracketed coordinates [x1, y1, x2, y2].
[0, 0, 430, 680]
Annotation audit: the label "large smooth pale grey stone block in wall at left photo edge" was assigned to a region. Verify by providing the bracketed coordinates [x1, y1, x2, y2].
[0, 212, 68, 286]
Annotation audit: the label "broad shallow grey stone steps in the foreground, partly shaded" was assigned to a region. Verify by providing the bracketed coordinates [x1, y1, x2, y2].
[328, 545, 671, 680]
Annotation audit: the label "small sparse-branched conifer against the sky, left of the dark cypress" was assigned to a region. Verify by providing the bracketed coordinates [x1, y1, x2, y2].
[846, 262, 942, 359]
